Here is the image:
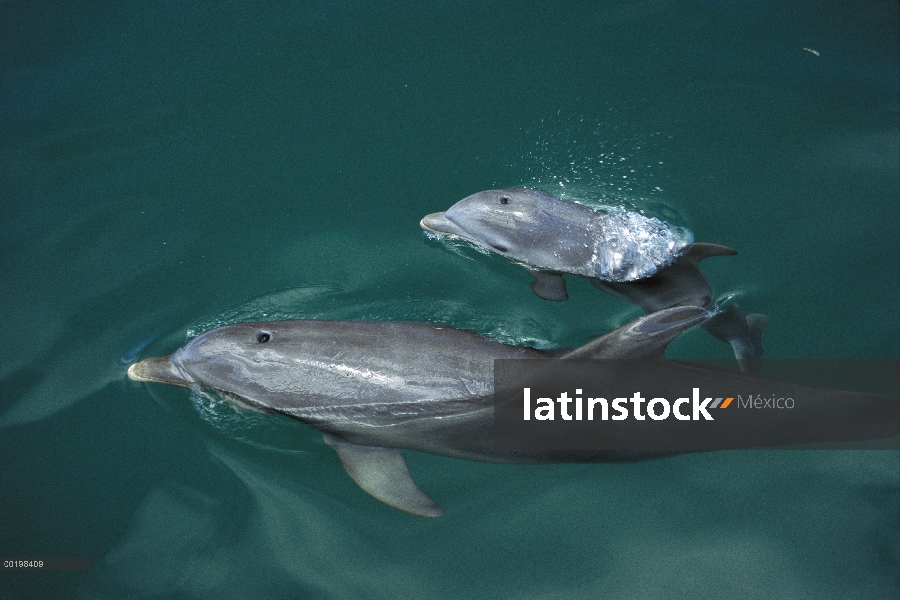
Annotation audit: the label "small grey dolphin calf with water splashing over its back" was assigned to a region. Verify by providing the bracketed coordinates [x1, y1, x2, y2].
[420, 189, 768, 370]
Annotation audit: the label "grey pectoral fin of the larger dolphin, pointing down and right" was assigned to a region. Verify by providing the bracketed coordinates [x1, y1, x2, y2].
[325, 433, 444, 517]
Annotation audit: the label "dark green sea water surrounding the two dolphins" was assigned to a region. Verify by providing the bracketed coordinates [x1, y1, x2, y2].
[0, 0, 900, 599]
